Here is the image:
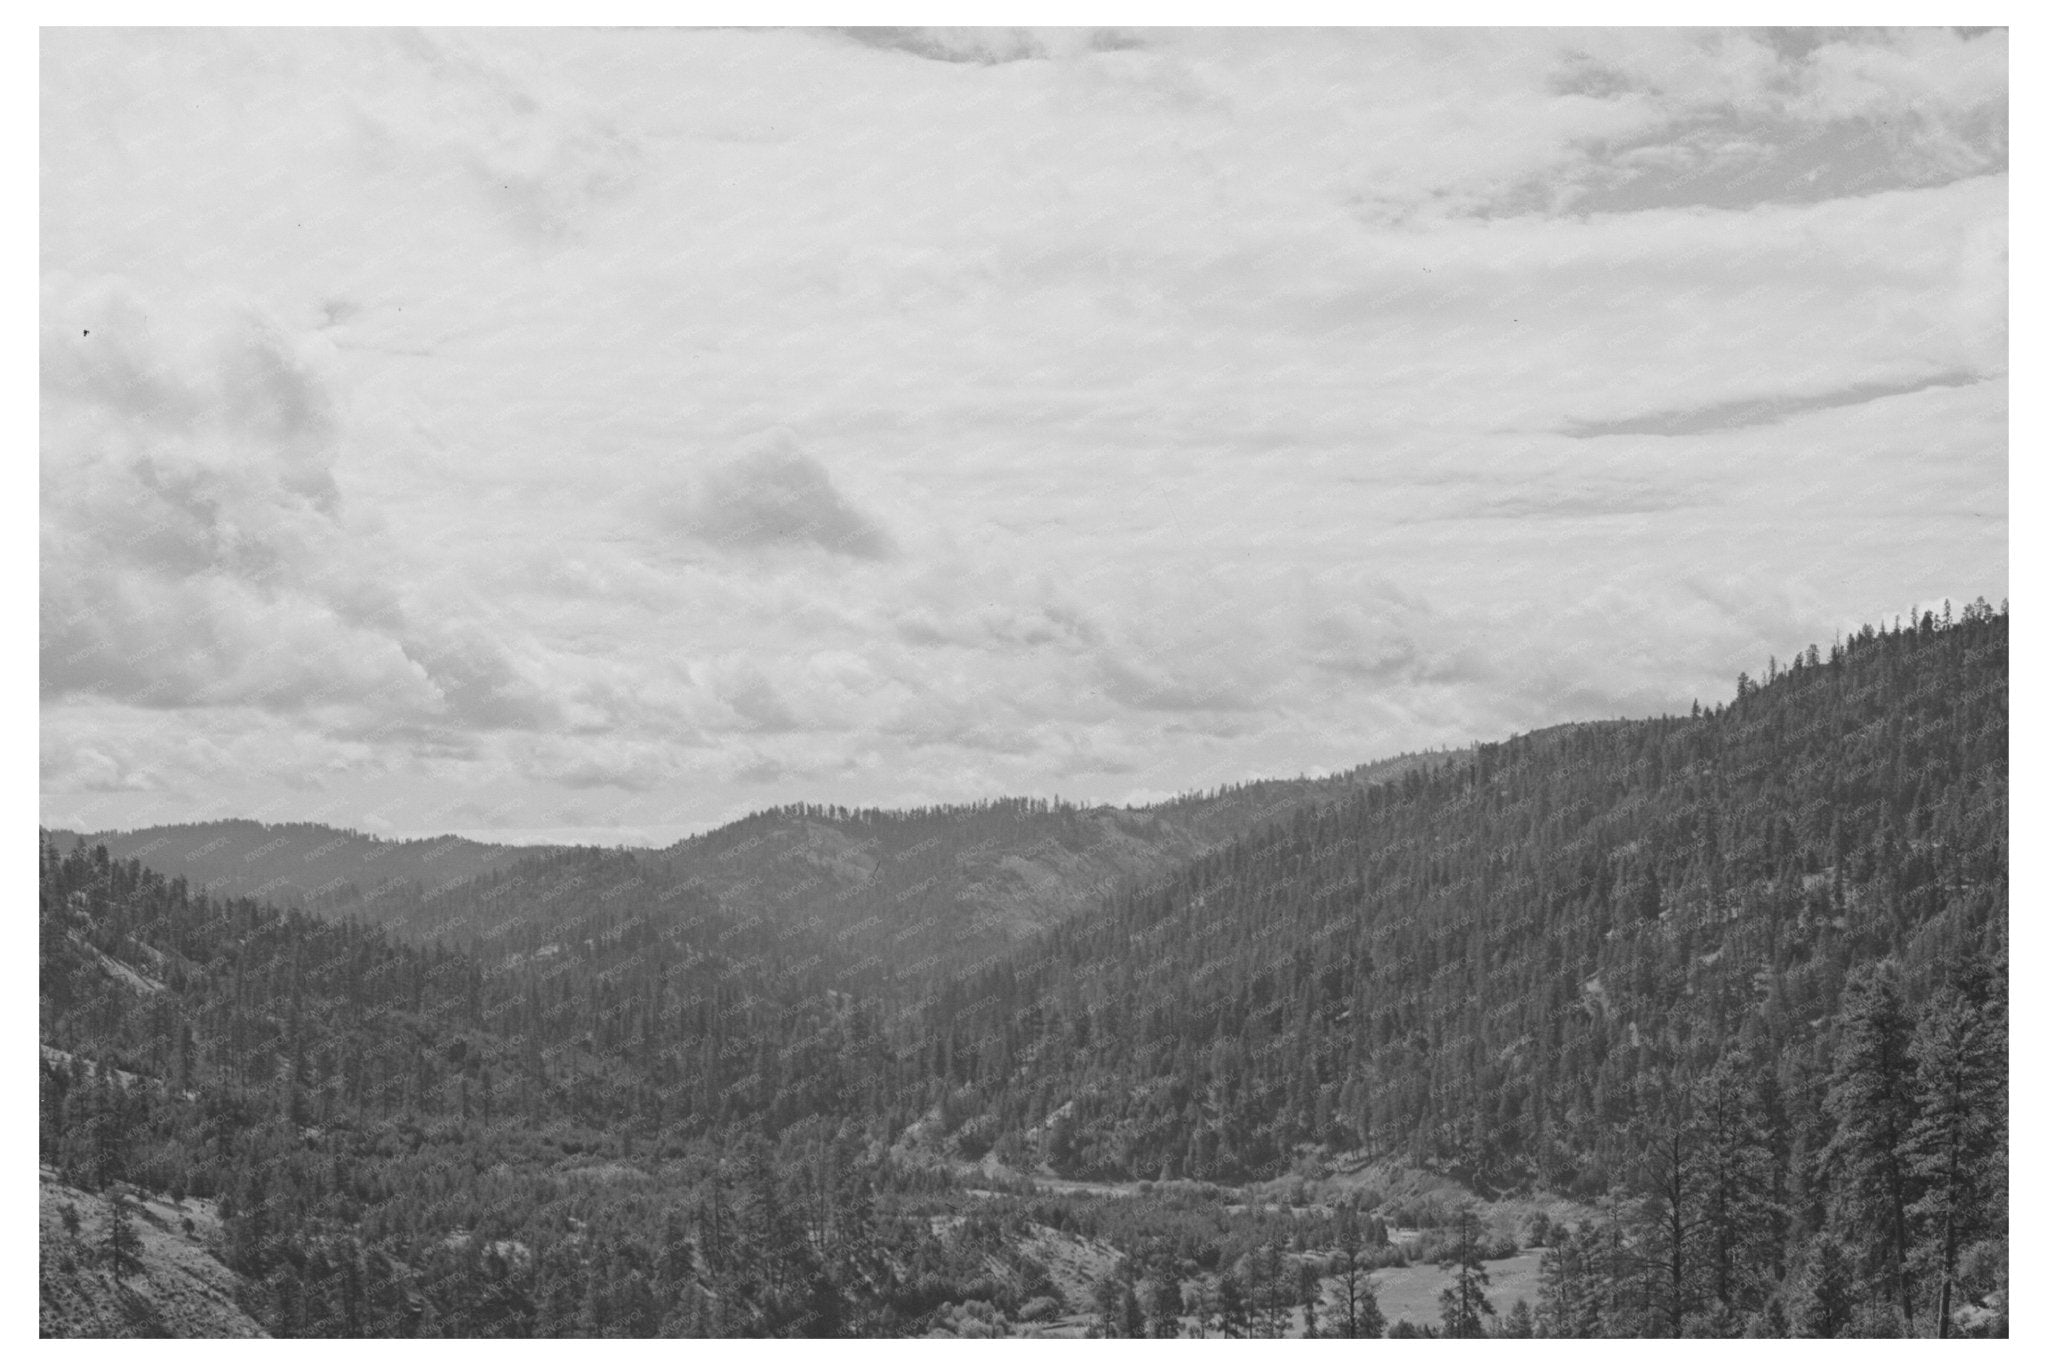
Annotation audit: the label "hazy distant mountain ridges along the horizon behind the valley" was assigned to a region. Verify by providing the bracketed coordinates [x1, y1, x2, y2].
[51, 753, 1462, 990]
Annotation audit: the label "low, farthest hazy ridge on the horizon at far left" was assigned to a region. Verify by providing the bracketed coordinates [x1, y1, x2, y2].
[49, 821, 543, 913]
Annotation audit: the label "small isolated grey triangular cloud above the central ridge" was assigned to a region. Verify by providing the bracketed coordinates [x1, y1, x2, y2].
[686, 430, 895, 561]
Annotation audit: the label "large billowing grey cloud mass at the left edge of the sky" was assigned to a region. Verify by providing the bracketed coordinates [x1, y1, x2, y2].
[41, 274, 555, 731]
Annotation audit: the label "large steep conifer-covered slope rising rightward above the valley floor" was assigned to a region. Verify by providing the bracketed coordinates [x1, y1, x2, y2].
[905, 610, 2007, 1191]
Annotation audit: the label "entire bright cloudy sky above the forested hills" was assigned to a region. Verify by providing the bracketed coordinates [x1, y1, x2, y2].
[39, 29, 2009, 843]
